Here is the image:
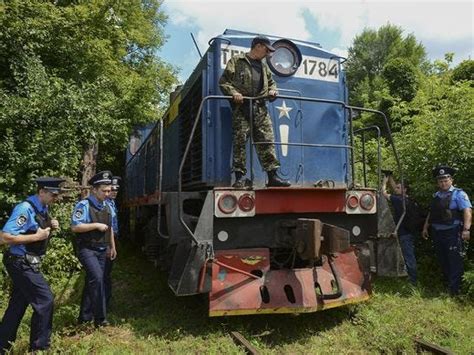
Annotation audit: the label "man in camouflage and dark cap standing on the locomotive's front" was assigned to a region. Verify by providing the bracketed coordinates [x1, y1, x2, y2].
[219, 36, 290, 188]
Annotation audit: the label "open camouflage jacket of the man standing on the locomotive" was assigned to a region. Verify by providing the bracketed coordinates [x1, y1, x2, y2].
[219, 54, 277, 96]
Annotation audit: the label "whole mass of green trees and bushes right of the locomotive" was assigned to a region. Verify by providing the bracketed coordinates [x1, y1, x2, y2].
[346, 25, 474, 294]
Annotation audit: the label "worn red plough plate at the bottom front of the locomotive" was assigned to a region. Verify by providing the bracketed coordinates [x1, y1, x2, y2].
[209, 248, 371, 316]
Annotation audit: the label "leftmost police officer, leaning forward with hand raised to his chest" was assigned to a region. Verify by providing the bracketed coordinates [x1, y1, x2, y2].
[0, 178, 65, 354]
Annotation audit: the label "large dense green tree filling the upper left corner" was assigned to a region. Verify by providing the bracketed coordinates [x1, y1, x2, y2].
[0, 0, 176, 210]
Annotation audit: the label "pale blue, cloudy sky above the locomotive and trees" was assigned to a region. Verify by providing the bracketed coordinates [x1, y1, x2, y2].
[160, 0, 474, 81]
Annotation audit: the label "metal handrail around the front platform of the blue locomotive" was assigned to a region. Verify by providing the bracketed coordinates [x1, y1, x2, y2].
[178, 95, 406, 244]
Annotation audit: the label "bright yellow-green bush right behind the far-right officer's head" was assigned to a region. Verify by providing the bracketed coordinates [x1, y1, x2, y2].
[386, 76, 474, 203]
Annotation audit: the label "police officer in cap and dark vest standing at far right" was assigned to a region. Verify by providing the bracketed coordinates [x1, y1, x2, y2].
[423, 165, 472, 295]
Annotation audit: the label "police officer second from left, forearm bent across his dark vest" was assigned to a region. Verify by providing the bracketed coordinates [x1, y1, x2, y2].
[71, 171, 117, 327]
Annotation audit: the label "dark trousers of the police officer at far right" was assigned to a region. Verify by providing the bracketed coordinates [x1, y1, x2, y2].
[432, 226, 464, 295]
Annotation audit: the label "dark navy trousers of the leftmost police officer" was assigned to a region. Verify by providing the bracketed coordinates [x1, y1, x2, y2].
[0, 256, 54, 353]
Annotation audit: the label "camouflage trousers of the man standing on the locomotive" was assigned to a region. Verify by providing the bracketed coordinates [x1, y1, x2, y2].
[232, 103, 280, 174]
